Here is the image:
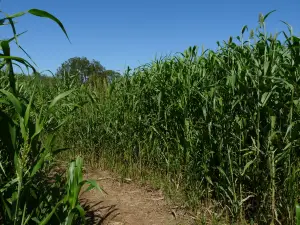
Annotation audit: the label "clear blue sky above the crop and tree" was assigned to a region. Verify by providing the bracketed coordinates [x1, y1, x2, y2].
[0, 0, 300, 72]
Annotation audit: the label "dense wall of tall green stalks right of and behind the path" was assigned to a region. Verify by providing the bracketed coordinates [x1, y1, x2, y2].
[0, 7, 300, 225]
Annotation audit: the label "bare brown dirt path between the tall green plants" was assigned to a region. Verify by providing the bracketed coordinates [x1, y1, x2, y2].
[82, 170, 193, 225]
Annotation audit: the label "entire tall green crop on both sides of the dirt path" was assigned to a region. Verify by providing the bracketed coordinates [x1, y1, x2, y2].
[0, 9, 300, 225]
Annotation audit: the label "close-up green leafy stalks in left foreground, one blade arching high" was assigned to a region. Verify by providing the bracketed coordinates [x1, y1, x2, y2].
[0, 9, 100, 225]
